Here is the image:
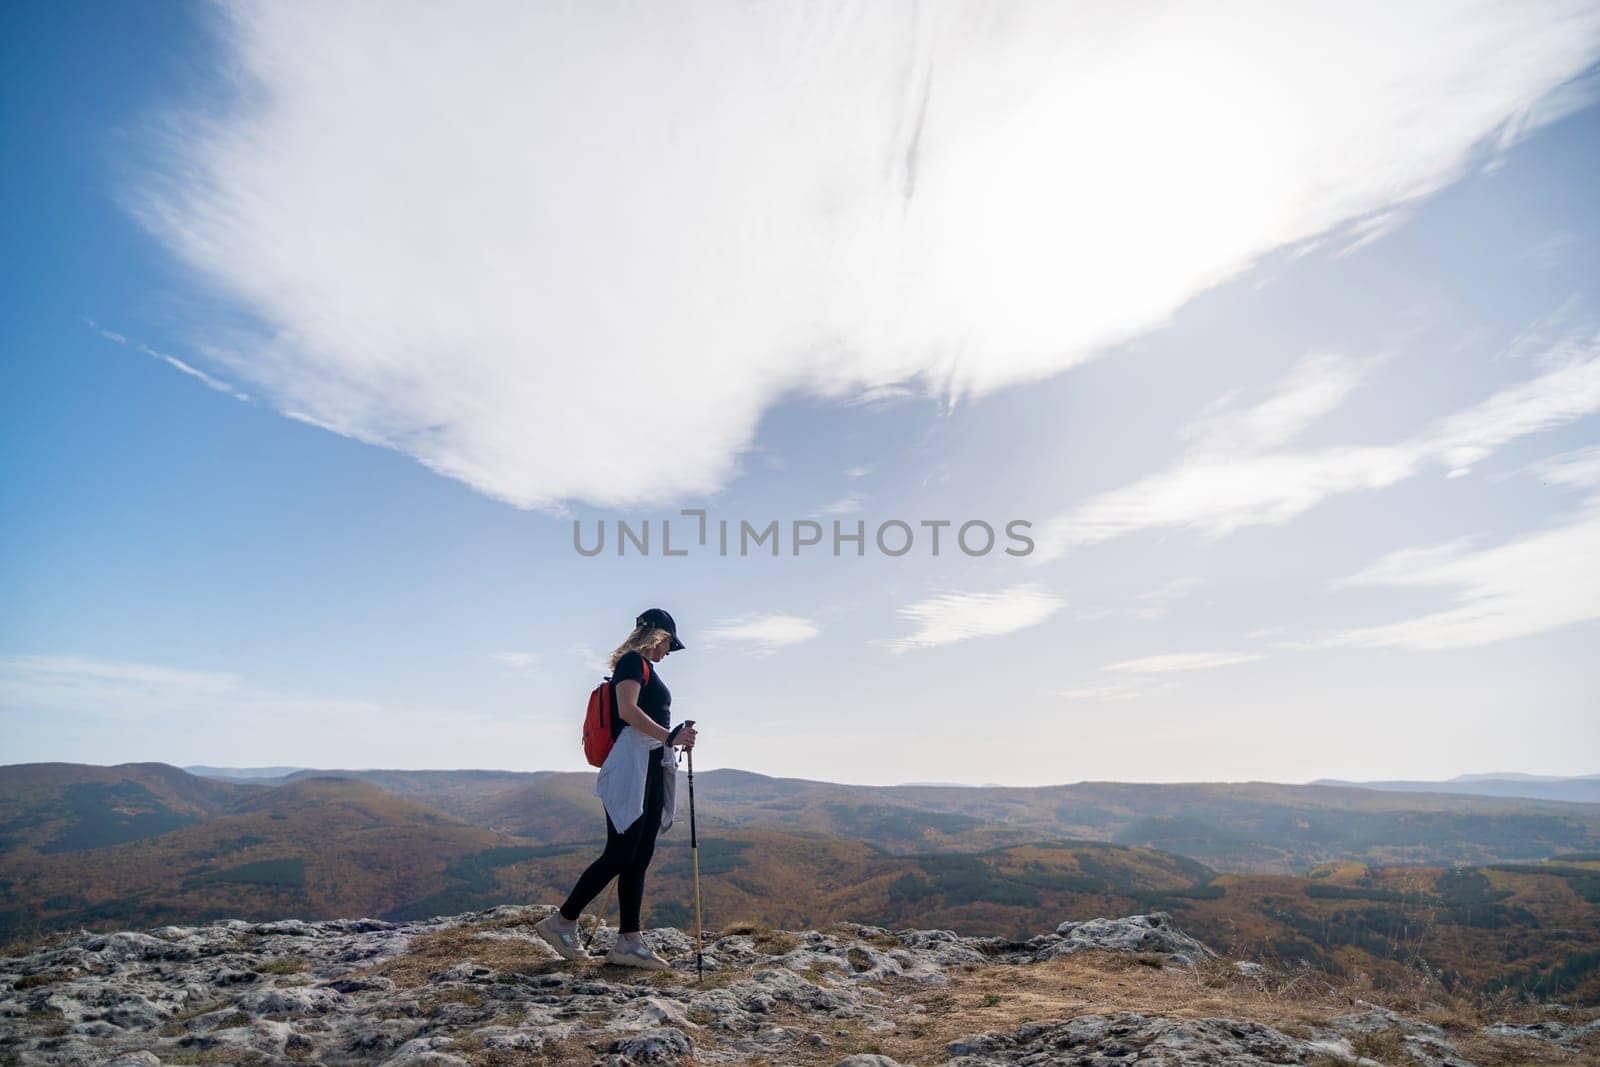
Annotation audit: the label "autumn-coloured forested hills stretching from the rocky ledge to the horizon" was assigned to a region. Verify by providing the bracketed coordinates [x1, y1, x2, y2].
[0, 763, 1600, 998]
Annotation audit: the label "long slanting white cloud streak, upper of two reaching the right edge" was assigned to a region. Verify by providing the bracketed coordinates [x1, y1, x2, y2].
[1027, 334, 1600, 565]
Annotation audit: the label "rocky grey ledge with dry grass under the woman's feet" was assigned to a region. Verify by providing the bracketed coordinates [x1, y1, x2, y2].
[0, 905, 1600, 1067]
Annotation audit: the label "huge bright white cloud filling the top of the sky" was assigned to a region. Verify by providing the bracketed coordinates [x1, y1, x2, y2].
[130, 0, 1600, 514]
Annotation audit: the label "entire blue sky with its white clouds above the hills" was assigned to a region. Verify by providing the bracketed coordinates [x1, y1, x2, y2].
[0, 5, 1600, 785]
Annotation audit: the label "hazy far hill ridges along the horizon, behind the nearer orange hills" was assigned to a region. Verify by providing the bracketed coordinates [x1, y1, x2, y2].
[173, 768, 1600, 873]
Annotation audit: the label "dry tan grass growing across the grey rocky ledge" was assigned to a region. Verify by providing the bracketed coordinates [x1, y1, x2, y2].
[353, 921, 1600, 1067]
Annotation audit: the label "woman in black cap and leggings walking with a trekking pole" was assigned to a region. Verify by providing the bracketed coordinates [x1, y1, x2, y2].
[534, 608, 694, 971]
